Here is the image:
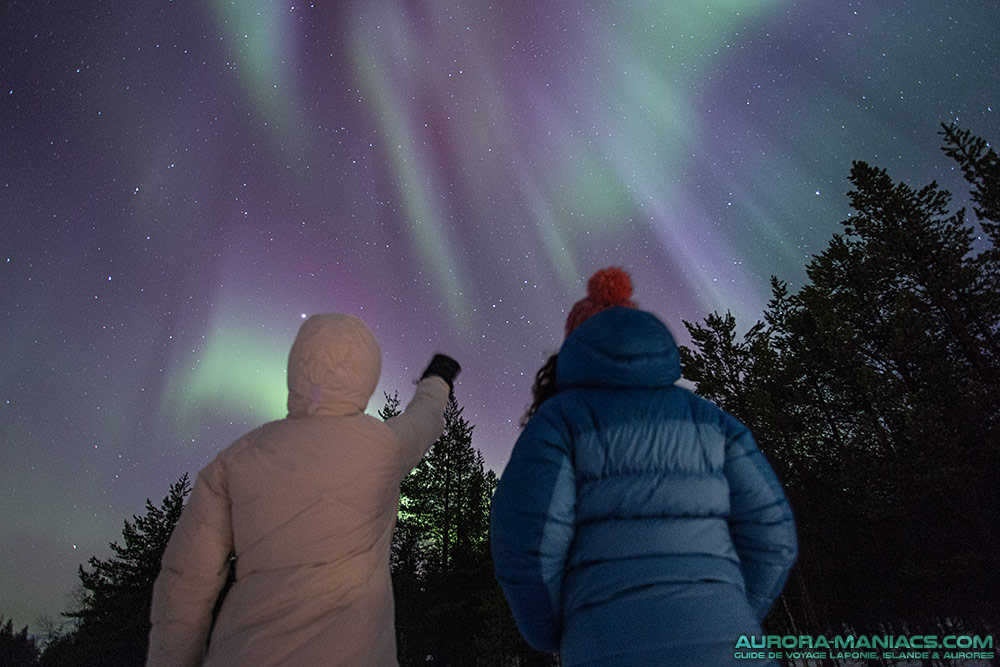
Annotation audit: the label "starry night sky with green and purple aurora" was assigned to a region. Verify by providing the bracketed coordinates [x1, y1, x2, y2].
[0, 0, 1000, 628]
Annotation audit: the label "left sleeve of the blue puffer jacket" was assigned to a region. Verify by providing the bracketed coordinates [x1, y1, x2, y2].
[490, 411, 576, 653]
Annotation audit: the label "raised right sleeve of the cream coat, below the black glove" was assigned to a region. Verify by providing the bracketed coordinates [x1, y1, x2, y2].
[385, 375, 449, 478]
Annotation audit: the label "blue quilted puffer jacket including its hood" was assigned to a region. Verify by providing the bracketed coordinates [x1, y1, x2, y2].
[491, 308, 796, 667]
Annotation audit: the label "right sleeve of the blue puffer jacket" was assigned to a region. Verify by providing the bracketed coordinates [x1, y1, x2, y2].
[725, 415, 798, 619]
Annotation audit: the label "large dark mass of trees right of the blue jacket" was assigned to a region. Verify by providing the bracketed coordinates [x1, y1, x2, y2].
[681, 126, 1000, 634]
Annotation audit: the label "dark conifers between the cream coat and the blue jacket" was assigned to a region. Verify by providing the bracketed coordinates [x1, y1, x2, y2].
[379, 394, 552, 667]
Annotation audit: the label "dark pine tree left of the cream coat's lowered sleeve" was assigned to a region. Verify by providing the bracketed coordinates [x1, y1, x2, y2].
[42, 474, 191, 667]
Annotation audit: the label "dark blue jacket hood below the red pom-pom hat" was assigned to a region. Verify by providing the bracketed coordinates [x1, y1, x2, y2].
[556, 307, 681, 390]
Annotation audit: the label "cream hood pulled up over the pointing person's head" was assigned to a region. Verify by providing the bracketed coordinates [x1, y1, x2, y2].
[288, 313, 382, 417]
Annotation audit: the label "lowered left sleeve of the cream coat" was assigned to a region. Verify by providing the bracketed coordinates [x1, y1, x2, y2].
[146, 459, 233, 667]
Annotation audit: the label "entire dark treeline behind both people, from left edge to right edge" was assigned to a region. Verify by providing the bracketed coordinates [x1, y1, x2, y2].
[0, 127, 1000, 667]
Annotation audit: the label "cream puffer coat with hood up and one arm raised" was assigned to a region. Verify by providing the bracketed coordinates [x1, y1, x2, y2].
[147, 314, 449, 667]
